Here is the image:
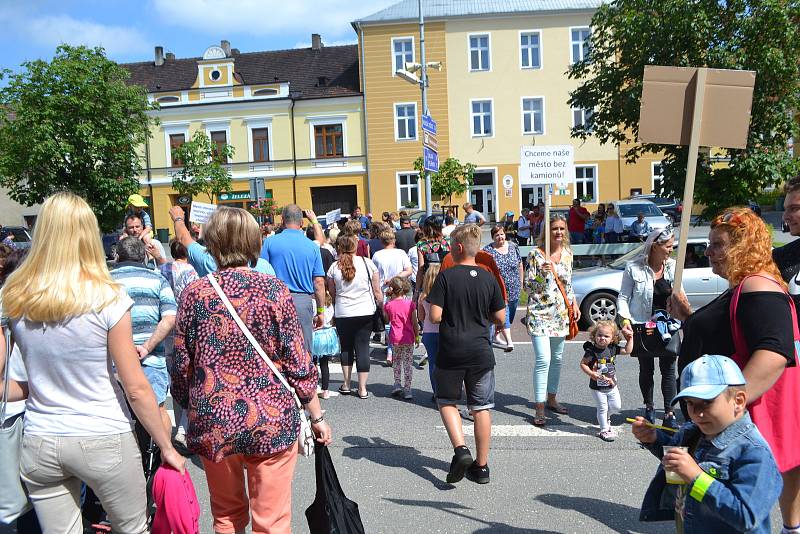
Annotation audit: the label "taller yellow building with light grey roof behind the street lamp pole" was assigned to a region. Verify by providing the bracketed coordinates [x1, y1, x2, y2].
[353, 0, 660, 219]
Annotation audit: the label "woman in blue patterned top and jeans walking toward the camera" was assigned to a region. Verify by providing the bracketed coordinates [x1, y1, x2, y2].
[483, 225, 525, 352]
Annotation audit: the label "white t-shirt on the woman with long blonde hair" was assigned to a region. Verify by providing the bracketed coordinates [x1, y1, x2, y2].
[10, 294, 133, 436]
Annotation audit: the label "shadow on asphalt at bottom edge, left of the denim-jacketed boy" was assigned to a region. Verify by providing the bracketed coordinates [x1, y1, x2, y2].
[536, 493, 675, 534]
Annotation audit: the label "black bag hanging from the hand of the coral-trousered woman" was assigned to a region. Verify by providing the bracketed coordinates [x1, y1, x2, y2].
[306, 443, 365, 534]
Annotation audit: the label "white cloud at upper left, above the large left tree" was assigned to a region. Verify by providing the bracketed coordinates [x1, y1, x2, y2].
[17, 15, 150, 58]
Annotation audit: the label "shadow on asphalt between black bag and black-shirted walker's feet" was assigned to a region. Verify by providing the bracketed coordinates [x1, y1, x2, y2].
[342, 436, 455, 490]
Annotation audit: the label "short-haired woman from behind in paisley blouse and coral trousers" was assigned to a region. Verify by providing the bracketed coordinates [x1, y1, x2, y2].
[172, 207, 331, 532]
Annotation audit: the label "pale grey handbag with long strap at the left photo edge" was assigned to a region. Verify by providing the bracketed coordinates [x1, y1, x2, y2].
[0, 328, 30, 523]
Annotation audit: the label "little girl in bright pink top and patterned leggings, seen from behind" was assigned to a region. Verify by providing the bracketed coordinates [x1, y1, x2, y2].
[383, 276, 419, 400]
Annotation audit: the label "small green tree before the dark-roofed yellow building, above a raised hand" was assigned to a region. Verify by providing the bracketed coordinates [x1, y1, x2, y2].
[172, 131, 233, 203]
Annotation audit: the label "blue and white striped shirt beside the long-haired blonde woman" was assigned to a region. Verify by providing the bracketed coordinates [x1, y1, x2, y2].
[111, 262, 178, 368]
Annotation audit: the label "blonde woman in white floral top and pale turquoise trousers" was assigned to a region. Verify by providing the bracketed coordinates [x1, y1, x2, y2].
[525, 215, 580, 426]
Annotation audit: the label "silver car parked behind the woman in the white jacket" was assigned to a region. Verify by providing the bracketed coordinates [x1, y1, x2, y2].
[572, 241, 728, 327]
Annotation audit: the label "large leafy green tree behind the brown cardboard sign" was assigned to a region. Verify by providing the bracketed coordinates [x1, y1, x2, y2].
[568, 0, 800, 218]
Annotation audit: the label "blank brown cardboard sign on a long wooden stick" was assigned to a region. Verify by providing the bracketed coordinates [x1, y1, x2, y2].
[639, 65, 756, 294]
